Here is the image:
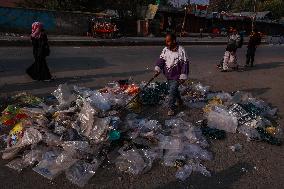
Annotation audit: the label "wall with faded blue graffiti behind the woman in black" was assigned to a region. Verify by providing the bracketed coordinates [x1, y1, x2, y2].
[0, 7, 92, 35]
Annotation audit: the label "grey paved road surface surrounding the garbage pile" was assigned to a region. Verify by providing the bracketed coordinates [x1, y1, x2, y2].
[0, 46, 284, 189]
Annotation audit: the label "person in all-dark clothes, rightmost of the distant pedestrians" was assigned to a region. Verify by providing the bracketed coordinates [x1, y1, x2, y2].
[245, 29, 261, 67]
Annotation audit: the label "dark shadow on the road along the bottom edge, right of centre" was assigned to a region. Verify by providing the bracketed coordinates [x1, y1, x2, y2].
[156, 162, 253, 189]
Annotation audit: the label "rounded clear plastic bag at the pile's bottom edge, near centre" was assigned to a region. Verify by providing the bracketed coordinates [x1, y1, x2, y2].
[116, 149, 147, 175]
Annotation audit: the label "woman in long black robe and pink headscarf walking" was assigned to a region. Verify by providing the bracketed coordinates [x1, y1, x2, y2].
[26, 22, 52, 81]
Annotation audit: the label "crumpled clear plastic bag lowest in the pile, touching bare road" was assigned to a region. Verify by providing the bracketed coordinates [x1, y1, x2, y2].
[65, 159, 100, 187]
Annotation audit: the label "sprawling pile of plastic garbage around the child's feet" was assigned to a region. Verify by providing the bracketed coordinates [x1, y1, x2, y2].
[0, 80, 281, 187]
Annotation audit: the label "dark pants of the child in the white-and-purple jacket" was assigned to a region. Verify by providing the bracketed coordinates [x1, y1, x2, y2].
[168, 80, 181, 110]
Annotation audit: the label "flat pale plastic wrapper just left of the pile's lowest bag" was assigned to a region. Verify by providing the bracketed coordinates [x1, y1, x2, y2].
[33, 151, 77, 180]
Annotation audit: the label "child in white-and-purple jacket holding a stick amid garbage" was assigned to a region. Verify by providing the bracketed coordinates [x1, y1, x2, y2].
[155, 34, 189, 116]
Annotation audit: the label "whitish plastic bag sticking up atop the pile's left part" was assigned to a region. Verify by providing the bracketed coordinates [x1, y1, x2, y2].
[52, 84, 76, 108]
